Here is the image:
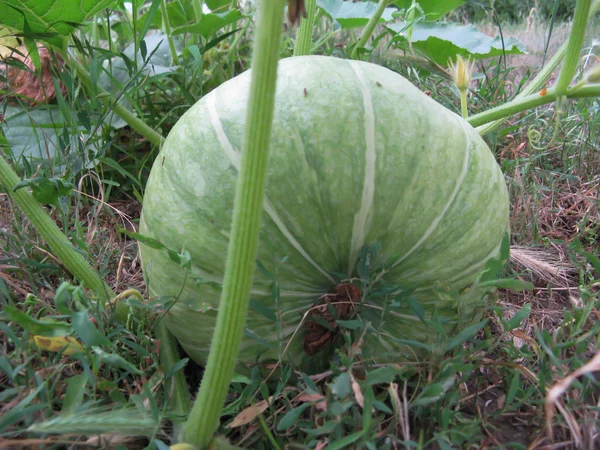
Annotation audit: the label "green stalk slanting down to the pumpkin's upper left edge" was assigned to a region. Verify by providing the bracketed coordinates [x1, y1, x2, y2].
[54, 43, 164, 147]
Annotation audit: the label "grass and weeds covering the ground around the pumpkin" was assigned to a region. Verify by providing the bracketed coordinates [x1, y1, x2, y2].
[0, 4, 600, 449]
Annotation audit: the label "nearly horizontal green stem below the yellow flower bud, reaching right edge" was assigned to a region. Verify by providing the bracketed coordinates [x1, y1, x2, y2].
[467, 84, 600, 127]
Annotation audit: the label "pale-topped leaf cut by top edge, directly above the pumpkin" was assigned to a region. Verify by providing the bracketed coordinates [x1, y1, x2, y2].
[317, 0, 396, 28]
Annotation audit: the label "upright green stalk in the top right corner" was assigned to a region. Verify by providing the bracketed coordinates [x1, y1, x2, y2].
[555, 0, 592, 95]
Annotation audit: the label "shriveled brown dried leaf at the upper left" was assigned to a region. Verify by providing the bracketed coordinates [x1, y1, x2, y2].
[0, 44, 67, 106]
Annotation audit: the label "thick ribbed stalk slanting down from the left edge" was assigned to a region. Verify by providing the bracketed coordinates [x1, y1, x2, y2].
[0, 155, 127, 322]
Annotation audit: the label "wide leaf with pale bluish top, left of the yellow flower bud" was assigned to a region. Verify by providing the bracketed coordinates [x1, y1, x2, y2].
[386, 23, 526, 65]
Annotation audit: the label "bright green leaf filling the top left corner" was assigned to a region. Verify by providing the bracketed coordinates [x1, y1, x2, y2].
[0, 0, 116, 45]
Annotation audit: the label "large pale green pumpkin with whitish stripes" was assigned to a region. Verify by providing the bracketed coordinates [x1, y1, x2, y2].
[140, 56, 509, 364]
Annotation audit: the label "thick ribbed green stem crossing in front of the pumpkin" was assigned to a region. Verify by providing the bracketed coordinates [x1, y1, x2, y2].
[183, 0, 285, 448]
